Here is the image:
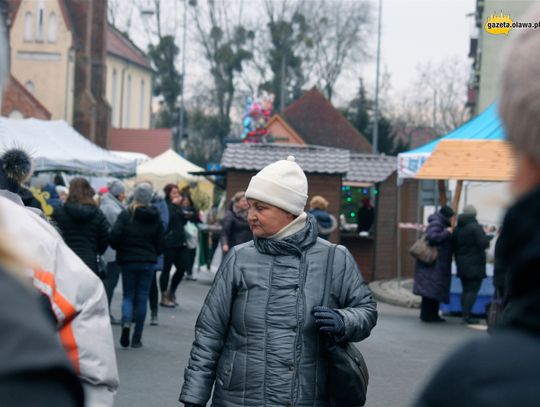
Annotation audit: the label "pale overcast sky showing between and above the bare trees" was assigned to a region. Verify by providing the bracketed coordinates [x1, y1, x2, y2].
[127, 0, 476, 105]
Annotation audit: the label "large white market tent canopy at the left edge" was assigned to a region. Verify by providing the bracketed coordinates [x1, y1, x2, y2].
[0, 117, 136, 177]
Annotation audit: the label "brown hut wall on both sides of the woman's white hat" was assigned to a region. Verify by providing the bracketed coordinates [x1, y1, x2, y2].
[227, 170, 341, 243]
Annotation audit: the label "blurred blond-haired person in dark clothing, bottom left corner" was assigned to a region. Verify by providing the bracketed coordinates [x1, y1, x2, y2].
[0, 230, 84, 407]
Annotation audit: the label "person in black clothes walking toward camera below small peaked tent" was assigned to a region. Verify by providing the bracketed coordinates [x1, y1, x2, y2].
[159, 184, 188, 308]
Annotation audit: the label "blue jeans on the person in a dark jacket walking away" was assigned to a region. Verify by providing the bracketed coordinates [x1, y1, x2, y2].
[122, 263, 155, 339]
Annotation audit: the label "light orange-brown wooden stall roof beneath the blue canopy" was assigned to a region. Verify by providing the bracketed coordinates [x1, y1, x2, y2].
[416, 140, 515, 181]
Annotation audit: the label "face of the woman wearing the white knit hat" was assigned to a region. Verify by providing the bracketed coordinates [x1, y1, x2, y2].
[247, 199, 294, 238]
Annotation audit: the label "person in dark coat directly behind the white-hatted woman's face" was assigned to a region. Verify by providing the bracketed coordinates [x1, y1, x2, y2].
[220, 191, 253, 253]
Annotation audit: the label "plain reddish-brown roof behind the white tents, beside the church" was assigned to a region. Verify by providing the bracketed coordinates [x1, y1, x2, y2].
[108, 128, 172, 158]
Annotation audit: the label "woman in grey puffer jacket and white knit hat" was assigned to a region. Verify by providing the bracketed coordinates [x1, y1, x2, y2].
[180, 157, 377, 407]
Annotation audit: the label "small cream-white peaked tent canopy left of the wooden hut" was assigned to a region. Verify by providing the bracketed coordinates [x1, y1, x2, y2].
[137, 149, 205, 183]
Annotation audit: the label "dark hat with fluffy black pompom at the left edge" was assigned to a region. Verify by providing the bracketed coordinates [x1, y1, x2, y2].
[0, 148, 32, 192]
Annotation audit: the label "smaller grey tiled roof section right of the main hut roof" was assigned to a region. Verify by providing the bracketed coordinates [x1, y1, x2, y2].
[344, 154, 397, 183]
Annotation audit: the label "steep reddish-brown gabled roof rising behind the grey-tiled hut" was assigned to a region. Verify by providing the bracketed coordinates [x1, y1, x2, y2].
[282, 88, 372, 153]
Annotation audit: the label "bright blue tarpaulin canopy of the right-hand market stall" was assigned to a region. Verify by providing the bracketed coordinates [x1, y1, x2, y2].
[398, 103, 506, 178]
